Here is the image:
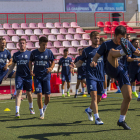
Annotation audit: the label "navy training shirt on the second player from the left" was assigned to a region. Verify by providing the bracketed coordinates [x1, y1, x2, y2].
[13, 50, 32, 79]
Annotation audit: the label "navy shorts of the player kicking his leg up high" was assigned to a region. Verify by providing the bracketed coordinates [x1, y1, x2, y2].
[105, 61, 130, 89]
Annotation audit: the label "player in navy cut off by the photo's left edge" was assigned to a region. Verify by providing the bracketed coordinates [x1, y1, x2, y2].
[0, 38, 16, 84]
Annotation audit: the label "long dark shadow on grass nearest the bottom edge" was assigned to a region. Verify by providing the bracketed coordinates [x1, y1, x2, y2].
[18, 129, 122, 140]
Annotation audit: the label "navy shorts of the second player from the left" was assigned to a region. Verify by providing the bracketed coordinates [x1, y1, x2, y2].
[15, 75, 32, 91]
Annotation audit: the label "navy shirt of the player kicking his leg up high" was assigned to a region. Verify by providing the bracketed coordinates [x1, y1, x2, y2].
[97, 40, 136, 70]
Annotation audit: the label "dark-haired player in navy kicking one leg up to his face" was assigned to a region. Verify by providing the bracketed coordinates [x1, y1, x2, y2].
[91, 26, 140, 130]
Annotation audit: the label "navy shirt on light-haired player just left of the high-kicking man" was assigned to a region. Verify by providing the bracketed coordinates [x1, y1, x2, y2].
[81, 46, 104, 81]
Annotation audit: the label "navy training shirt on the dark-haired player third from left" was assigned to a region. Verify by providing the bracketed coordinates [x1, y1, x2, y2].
[30, 49, 54, 80]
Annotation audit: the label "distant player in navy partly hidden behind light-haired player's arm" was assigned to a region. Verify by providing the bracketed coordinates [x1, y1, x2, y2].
[74, 49, 86, 98]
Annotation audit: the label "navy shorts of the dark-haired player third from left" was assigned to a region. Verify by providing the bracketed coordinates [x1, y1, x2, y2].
[34, 78, 51, 94]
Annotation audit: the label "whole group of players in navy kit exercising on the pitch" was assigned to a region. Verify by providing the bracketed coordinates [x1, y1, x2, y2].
[0, 26, 140, 130]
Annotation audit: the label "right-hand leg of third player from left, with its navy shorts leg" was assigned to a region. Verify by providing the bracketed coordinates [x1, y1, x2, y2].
[42, 80, 51, 115]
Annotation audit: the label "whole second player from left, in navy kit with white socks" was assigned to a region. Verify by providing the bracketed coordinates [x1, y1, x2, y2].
[5, 38, 35, 118]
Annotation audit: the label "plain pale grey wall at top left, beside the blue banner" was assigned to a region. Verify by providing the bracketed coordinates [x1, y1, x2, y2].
[0, 0, 64, 13]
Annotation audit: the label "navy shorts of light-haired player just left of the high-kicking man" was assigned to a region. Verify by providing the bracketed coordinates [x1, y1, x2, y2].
[86, 79, 104, 96]
